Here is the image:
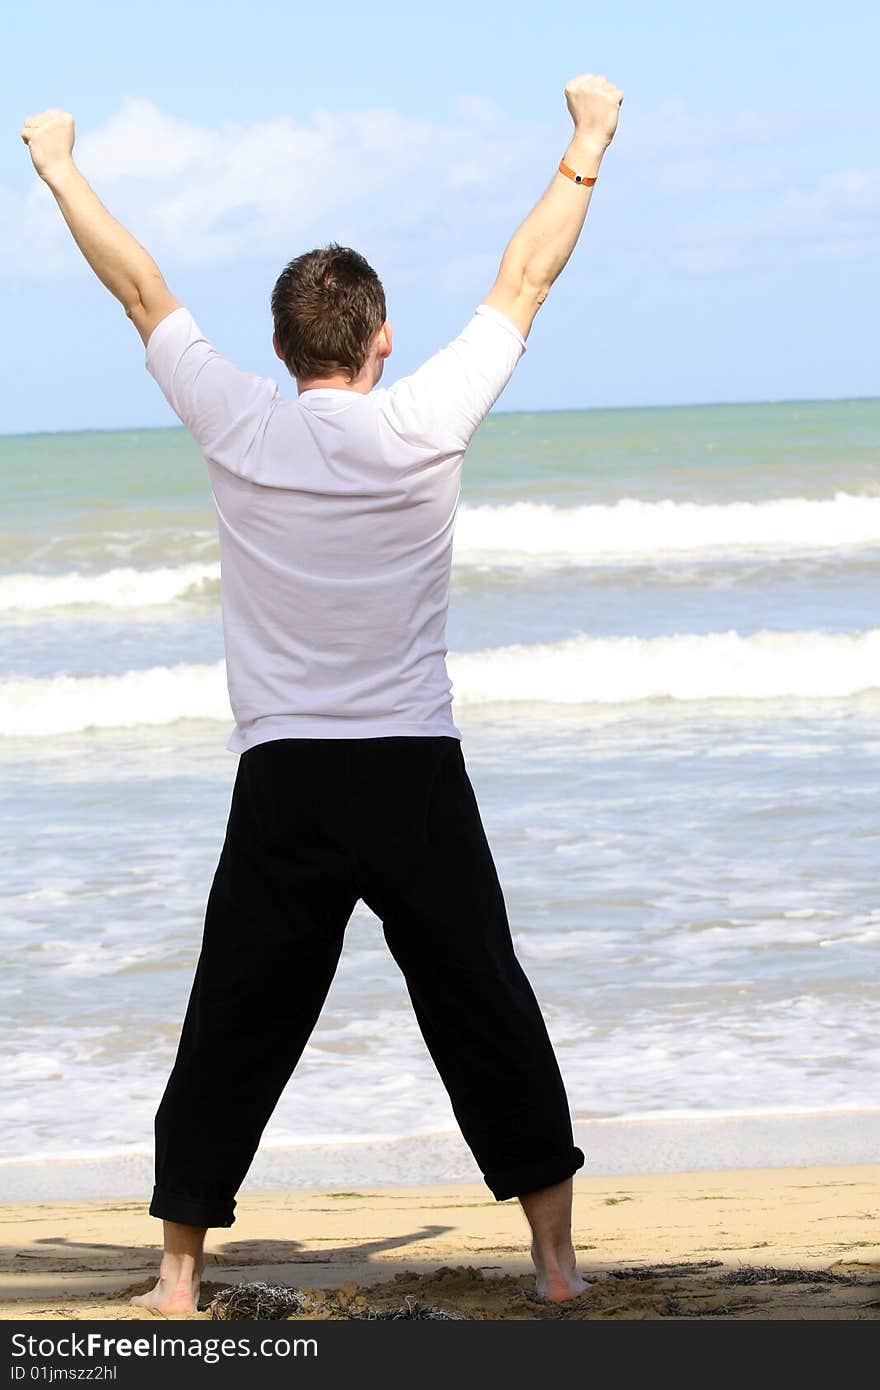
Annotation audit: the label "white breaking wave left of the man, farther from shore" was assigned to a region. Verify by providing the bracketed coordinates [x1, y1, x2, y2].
[0, 563, 220, 613]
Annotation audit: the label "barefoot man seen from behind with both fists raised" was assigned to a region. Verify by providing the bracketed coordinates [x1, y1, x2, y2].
[21, 75, 623, 1314]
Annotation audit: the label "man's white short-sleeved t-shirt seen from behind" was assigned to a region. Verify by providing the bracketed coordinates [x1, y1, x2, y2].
[146, 304, 525, 753]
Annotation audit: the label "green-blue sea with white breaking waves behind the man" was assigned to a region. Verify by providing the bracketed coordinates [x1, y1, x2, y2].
[0, 400, 880, 1197]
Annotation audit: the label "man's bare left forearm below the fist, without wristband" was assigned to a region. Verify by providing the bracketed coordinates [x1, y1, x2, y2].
[44, 160, 165, 314]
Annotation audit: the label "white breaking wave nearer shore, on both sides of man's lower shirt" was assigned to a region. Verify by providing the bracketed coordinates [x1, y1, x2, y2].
[0, 628, 880, 737]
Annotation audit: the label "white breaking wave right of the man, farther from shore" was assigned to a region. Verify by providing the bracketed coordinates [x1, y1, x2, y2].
[455, 492, 880, 564]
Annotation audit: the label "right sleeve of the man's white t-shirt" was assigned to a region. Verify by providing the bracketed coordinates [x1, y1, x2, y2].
[385, 304, 525, 452]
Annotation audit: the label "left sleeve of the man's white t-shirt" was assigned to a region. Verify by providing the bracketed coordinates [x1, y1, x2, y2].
[145, 307, 279, 477]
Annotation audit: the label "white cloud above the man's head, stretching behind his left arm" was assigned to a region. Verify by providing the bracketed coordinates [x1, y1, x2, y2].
[0, 97, 541, 274]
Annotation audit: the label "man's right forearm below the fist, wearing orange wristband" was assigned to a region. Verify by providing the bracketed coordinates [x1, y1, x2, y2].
[500, 135, 605, 303]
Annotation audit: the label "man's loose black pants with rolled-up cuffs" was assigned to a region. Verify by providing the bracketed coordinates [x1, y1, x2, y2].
[150, 735, 584, 1226]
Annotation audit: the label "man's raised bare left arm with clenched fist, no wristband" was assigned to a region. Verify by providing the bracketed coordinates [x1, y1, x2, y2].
[21, 110, 182, 343]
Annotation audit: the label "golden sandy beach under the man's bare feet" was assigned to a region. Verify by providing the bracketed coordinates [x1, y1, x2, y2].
[0, 1166, 880, 1321]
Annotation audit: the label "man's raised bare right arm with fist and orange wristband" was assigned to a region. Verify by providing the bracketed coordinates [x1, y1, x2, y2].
[484, 74, 623, 338]
